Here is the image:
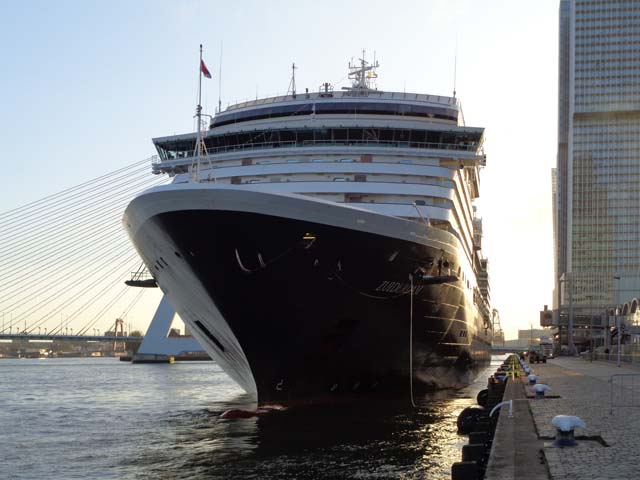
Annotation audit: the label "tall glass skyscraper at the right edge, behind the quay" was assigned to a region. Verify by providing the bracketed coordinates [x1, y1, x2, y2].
[552, 0, 640, 314]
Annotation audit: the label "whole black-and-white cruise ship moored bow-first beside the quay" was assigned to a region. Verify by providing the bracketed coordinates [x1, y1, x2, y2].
[123, 55, 491, 404]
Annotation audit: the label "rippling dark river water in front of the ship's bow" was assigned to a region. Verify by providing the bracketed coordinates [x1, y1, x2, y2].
[0, 358, 500, 480]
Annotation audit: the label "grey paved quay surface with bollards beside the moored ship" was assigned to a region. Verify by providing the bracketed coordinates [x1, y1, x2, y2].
[485, 358, 640, 480]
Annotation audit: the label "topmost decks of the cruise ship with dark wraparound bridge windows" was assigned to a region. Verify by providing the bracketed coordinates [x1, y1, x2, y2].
[153, 85, 484, 167]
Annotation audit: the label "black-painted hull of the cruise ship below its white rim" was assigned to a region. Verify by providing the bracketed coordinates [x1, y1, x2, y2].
[142, 210, 490, 403]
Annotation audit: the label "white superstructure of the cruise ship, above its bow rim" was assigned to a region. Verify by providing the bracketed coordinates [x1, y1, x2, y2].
[154, 58, 486, 298]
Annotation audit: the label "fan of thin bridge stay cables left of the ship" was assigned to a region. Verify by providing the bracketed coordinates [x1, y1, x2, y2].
[0, 157, 169, 340]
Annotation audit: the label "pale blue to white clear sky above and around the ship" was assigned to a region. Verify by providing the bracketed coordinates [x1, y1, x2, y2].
[0, 0, 558, 338]
